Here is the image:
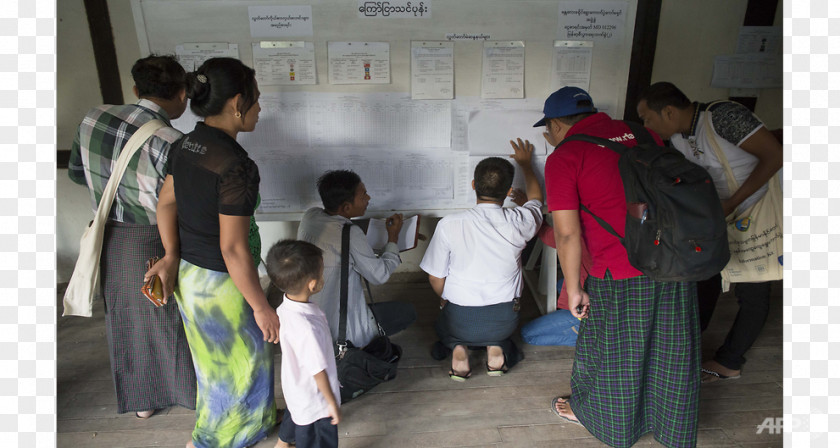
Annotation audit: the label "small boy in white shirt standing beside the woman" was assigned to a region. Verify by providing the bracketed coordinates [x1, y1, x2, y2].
[266, 240, 341, 448]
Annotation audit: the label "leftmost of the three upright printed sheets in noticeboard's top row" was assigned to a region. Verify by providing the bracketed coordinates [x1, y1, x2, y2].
[411, 41, 455, 100]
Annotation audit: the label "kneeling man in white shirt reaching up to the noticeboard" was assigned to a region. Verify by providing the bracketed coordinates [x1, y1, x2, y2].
[420, 140, 543, 381]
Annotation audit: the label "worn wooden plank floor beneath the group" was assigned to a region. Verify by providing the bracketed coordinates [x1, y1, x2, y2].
[57, 283, 783, 448]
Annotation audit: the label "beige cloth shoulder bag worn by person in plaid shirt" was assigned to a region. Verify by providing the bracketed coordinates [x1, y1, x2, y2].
[62, 120, 166, 317]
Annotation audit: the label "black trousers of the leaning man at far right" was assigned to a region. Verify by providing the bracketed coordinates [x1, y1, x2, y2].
[697, 274, 770, 370]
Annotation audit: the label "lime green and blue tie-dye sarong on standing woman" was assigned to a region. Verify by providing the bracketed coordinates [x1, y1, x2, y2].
[175, 260, 276, 448]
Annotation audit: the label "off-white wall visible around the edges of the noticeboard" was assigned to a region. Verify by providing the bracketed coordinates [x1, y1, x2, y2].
[56, 0, 783, 282]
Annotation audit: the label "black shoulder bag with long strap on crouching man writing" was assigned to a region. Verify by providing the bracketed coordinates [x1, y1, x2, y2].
[335, 224, 402, 403]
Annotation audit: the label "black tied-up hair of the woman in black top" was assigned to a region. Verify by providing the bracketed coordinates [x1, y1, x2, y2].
[187, 58, 258, 117]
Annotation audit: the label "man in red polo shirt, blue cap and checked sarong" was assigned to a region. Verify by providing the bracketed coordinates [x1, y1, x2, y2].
[534, 87, 701, 447]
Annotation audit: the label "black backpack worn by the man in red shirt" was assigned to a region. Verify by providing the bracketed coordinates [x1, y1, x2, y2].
[561, 122, 729, 282]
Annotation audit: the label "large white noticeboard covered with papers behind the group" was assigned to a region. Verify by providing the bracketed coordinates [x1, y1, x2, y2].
[130, 0, 636, 220]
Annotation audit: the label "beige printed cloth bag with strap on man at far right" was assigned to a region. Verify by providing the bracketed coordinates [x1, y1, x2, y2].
[706, 110, 784, 291]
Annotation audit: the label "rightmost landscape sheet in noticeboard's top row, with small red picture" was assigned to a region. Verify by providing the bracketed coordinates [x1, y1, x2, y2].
[327, 42, 391, 84]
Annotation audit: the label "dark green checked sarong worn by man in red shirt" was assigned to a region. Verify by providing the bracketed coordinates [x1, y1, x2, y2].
[570, 271, 701, 448]
